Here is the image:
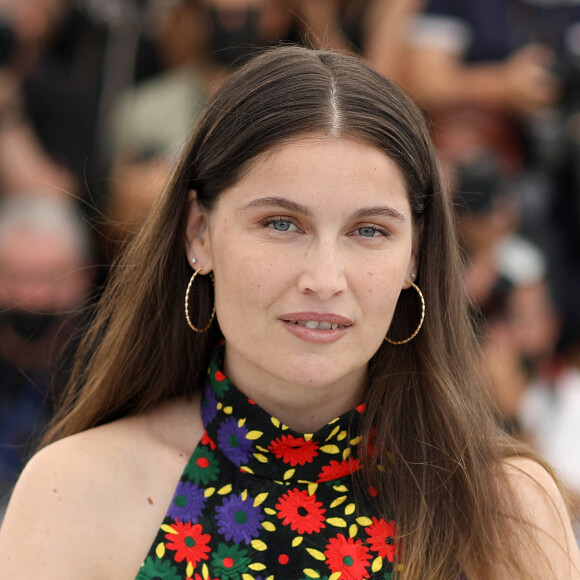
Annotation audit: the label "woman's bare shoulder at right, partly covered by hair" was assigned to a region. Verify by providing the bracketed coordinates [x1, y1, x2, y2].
[504, 457, 580, 580]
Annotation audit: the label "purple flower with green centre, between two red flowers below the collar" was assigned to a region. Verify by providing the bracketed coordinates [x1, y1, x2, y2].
[216, 495, 264, 544]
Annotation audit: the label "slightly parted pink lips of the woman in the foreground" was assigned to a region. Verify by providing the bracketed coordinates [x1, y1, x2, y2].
[280, 312, 352, 344]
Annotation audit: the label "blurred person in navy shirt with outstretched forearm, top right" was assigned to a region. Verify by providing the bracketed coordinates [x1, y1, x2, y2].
[396, 0, 580, 304]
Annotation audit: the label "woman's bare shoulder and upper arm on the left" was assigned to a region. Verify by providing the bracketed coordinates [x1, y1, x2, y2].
[0, 394, 203, 580]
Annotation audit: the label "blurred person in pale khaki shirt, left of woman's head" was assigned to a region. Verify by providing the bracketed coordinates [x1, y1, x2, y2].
[101, 0, 213, 244]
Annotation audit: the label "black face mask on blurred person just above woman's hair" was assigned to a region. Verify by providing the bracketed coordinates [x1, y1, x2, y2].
[209, 7, 265, 66]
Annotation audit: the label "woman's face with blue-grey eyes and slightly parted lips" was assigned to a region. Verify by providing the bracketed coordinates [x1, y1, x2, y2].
[187, 136, 415, 404]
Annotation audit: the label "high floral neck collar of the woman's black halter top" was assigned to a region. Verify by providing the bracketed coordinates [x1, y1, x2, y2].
[202, 345, 365, 483]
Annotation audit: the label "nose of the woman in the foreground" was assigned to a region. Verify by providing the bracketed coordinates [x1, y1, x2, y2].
[298, 242, 347, 300]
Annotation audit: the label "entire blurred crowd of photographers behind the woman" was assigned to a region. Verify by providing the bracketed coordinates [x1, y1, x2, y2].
[0, 0, 580, 536]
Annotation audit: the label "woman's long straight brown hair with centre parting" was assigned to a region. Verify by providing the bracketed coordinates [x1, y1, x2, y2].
[45, 47, 548, 580]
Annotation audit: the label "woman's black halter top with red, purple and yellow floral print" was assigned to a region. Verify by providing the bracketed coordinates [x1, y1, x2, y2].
[137, 348, 397, 580]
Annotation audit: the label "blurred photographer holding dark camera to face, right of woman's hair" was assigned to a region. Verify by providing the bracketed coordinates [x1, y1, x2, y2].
[448, 140, 559, 432]
